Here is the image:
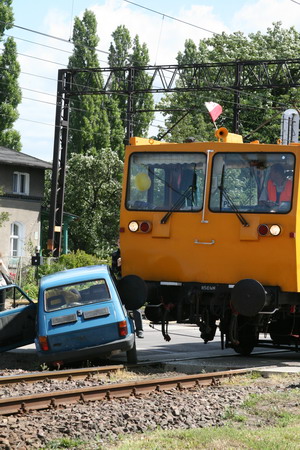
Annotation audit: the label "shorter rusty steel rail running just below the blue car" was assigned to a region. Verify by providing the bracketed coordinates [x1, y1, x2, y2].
[0, 364, 124, 386]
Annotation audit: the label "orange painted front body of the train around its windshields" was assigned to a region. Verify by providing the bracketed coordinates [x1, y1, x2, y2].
[120, 139, 300, 292]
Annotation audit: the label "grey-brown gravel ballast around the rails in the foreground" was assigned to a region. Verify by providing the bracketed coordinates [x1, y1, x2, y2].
[0, 372, 295, 450]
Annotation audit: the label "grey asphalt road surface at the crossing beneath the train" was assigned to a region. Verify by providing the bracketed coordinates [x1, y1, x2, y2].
[5, 320, 300, 373]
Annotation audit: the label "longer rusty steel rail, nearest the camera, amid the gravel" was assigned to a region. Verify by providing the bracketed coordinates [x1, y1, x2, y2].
[0, 369, 254, 415]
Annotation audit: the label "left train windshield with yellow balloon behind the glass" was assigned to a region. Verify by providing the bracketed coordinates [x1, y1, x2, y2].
[126, 152, 206, 211]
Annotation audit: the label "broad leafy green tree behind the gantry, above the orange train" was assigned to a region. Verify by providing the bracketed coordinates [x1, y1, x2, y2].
[157, 23, 300, 143]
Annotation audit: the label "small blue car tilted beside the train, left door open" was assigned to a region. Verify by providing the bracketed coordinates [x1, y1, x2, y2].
[0, 265, 137, 365]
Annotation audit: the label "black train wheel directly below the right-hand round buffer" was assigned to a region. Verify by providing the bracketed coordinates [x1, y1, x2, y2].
[231, 316, 258, 356]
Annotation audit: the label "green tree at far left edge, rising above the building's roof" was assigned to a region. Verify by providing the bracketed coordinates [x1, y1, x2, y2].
[0, 0, 22, 151]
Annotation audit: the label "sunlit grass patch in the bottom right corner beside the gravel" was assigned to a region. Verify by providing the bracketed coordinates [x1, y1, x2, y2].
[107, 388, 300, 450]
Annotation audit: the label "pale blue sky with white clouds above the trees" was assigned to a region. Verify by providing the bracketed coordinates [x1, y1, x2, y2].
[5, 0, 300, 161]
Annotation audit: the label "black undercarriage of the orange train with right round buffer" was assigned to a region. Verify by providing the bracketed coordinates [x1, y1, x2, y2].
[145, 279, 300, 355]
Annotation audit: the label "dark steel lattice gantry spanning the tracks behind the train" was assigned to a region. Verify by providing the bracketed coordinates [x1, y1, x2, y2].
[47, 59, 300, 256]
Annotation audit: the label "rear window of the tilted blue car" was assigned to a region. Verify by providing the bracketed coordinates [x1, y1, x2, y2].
[44, 279, 111, 312]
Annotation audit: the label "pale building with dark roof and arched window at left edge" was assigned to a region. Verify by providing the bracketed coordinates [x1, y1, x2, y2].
[0, 147, 52, 267]
